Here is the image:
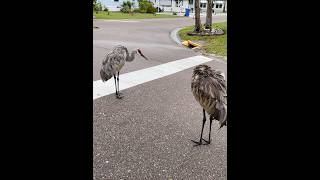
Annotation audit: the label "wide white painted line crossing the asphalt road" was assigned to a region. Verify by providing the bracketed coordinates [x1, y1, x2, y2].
[93, 56, 213, 100]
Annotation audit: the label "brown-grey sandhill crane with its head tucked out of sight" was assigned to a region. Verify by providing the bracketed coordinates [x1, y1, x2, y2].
[191, 65, 227, 146]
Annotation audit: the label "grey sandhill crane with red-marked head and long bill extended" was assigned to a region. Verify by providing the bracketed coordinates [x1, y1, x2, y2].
[100, 45, 148, 99]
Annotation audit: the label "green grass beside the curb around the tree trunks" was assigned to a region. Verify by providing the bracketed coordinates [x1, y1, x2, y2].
[179, 22, 227, 56]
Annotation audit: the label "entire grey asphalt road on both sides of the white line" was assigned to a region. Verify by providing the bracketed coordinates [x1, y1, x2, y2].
[93, 14, 227, 179]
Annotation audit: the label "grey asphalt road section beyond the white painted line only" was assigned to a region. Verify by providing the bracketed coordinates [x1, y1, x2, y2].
[93, 16, 226, 80]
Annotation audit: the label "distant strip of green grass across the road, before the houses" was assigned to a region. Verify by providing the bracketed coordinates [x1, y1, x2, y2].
[93, 11, 181, 19]
